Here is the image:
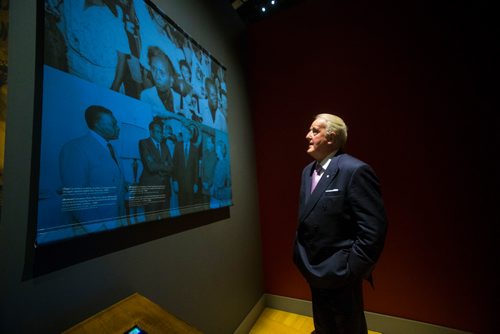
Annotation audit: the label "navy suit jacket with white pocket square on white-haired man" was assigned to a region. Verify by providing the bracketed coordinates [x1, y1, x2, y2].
[294, 151, 387, 288]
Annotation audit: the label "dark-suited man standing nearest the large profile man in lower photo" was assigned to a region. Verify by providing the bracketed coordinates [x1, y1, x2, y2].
[139, 120, 173, 220]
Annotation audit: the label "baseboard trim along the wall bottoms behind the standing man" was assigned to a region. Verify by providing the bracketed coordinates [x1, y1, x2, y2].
[234, 294, 471, 334]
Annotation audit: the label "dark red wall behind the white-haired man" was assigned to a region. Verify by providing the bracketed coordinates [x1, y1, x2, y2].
[247, 0, 499, 333]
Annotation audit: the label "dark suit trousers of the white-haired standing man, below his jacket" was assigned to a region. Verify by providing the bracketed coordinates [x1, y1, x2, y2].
[310, 280, 368, 334]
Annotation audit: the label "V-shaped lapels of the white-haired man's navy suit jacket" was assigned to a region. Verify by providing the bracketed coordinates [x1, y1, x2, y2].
[300, 155, 341, 221]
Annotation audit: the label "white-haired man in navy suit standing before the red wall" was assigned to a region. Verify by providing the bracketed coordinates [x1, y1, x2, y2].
[294, 114, 387, 334]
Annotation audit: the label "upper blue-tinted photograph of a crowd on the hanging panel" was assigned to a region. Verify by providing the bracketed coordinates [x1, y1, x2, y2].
[44, 0, 227, 132]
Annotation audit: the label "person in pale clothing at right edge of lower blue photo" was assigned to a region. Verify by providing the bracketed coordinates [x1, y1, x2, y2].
[210, 140, 231, 208]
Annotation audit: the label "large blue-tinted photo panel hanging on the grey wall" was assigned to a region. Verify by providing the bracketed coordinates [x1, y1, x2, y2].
[36, 0, 232, 244]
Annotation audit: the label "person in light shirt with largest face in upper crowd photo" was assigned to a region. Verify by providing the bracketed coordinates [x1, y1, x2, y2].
[141, 46, 180, 117]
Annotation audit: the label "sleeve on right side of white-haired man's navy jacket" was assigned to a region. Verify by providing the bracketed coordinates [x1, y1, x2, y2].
[348, 165, 387, 277]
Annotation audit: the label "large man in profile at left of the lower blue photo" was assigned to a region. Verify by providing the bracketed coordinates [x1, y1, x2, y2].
[59, 105, 126, 235]
